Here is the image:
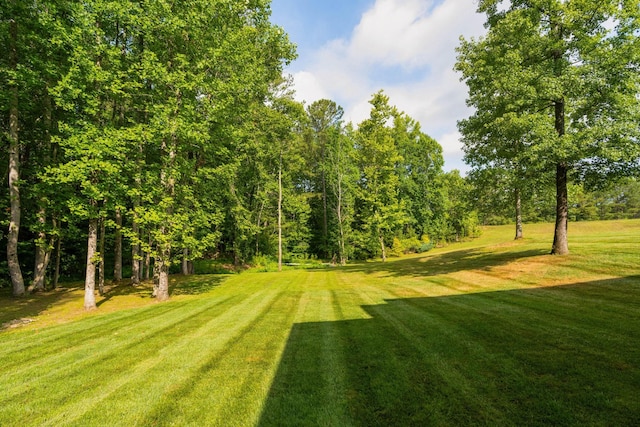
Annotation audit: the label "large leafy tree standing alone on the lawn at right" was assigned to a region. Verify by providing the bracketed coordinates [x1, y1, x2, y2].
[456, 0, 640, 254]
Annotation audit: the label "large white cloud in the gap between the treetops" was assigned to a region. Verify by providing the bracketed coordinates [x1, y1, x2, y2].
[294, 0, 484, 169]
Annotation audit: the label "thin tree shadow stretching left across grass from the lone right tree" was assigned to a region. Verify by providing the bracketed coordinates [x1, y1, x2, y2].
[340, 249, 549, 277]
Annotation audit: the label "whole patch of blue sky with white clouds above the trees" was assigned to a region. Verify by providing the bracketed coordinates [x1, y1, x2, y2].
[271, 0, 485, 174]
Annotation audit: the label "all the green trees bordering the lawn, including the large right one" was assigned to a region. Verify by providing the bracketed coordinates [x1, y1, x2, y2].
[0, 0, 640, 309]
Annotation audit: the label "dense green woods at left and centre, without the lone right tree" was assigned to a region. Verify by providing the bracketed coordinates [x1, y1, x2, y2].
[0, 0, 477, 309]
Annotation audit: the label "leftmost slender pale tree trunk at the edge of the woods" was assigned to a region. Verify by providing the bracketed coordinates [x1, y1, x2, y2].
[7, 10, 25, 296]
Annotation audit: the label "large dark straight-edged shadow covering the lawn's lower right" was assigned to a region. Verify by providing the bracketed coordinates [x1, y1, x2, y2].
[259, 276, 640, 426]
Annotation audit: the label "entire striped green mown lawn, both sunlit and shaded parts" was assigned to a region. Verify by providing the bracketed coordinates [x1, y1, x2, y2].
[0, 220, 640, 427]
